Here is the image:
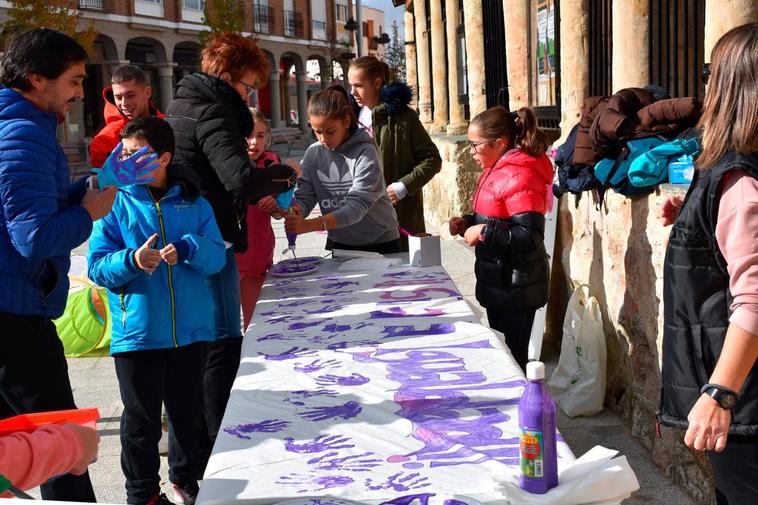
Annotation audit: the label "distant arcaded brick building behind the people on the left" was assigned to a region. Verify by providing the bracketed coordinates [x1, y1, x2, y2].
[0, 0, 352, 161]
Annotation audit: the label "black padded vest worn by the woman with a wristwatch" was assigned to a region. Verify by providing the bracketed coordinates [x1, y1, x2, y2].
[658, 152, 758, 436]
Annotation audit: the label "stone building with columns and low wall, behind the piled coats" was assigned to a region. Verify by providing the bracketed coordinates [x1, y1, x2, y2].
[395, 0, 758, 504]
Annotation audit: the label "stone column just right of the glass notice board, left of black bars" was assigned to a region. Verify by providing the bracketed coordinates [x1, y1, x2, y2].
[556, 0, 590, 145]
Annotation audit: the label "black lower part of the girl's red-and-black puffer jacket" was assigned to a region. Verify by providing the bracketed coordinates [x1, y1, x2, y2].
[467, 212, 550, 309]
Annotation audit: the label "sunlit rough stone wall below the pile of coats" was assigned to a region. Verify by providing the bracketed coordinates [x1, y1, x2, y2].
[543, 185, 713, 504]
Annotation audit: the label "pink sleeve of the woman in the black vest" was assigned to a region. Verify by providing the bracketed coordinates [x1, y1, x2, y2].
[716, 171, 758, 335]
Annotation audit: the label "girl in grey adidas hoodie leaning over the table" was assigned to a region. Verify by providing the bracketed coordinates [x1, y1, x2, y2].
[285, 87, 400, 254]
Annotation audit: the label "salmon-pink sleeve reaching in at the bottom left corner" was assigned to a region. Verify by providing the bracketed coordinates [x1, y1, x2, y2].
[0, 425, 84, 496]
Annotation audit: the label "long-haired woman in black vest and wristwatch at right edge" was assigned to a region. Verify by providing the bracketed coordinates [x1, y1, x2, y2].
[659, 23, 758, 505]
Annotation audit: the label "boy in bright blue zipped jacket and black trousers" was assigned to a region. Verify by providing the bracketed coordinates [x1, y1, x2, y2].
[88, 117, 225, 505]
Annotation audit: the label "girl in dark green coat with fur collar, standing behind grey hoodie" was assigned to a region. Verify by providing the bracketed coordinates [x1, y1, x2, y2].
[348, 56, 442, 251]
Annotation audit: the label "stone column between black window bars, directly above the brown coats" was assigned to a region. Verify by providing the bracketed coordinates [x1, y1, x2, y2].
[616, 0, 652, 93]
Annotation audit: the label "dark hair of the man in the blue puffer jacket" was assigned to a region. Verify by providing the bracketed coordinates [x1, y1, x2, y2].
[0, 28, 87, 91]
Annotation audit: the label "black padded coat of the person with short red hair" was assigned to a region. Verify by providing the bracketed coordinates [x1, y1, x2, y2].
[166, 73, 293, 252]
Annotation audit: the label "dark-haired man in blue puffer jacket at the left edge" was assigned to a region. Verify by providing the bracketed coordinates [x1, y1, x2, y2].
[0, 29, 116, 502]
